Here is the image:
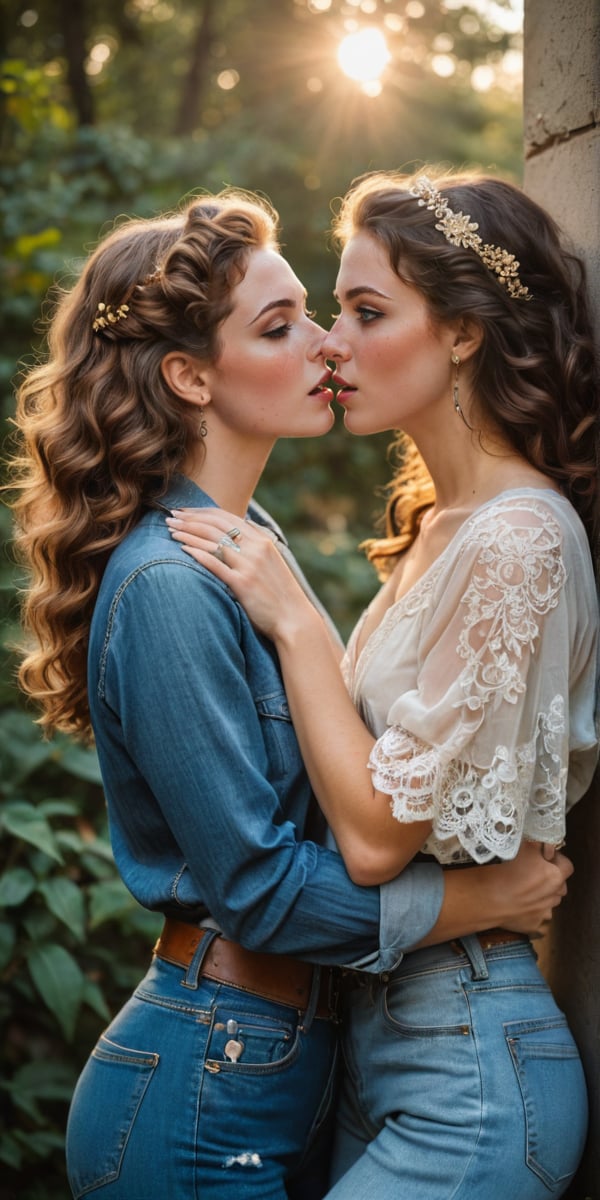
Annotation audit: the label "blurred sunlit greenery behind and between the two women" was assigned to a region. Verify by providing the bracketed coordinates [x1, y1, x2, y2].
[0, 0, 522, 1200]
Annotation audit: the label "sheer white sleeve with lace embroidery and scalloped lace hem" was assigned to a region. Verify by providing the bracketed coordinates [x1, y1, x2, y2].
[370, 503, 572, 863]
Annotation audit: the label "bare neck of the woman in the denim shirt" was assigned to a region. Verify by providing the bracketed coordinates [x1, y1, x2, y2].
[182, 426, 274, 517]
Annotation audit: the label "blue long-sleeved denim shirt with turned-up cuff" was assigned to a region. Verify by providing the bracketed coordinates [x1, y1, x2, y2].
[89, 476, 443, 971]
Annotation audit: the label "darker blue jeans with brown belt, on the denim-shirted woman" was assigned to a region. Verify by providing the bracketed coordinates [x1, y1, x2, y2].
[67, 959, 337, 1200]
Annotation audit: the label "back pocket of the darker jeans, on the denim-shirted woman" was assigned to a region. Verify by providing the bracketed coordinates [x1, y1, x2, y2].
[66, 1036, 158, 1200]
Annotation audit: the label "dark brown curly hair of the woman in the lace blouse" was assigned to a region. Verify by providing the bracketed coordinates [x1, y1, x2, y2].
[334, 168, 600, 575]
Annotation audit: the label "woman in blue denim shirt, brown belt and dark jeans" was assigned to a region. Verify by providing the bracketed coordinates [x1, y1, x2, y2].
[16, 193, 571, 1200]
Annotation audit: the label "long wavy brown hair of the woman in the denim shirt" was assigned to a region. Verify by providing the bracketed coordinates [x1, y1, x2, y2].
[8, 190, 278, 738]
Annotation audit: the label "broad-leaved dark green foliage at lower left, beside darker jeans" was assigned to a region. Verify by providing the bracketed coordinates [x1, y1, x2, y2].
[0, 667, 160, 1200]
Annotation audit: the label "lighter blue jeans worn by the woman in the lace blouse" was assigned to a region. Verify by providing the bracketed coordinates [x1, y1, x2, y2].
[328, 937, 587, 1200]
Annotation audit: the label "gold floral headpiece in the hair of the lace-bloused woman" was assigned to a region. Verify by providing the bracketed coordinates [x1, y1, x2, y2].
[410, 175, 533, 300]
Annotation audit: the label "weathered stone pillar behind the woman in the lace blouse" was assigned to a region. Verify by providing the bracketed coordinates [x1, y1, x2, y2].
[524, 0, 600, 1200]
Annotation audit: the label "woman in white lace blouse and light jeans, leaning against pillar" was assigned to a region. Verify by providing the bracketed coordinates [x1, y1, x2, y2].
[170, 174, 599, 1200]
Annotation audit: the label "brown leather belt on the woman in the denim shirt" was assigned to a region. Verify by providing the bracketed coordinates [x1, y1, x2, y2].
[154, 917, 337, 1019]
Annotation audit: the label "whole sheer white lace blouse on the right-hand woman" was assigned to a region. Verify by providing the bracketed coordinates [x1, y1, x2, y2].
[343, 488, 599, 863]
